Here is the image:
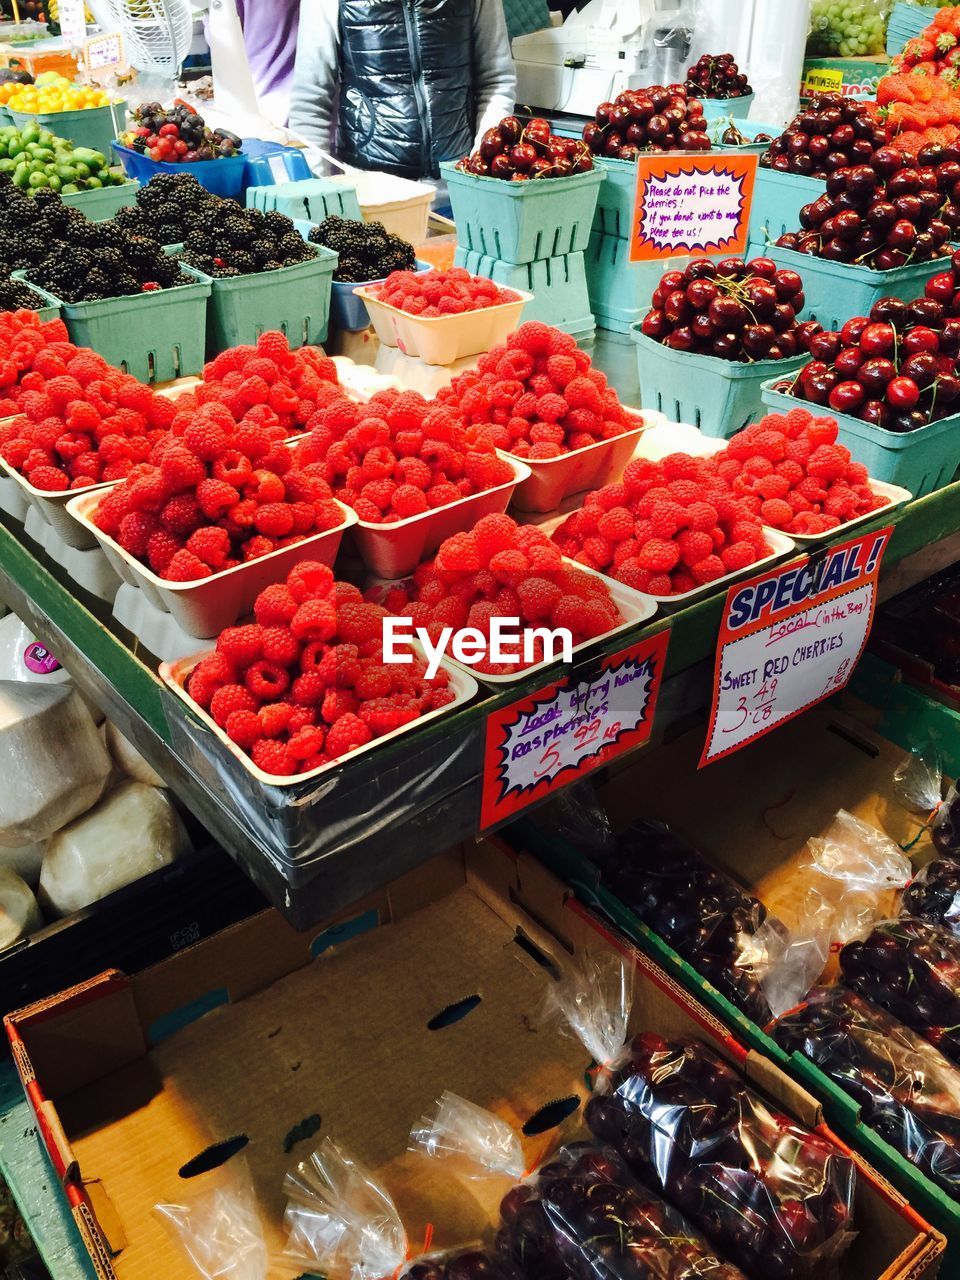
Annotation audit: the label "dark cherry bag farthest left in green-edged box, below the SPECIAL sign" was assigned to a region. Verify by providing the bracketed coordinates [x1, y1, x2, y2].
[594, 820, 788, 1024]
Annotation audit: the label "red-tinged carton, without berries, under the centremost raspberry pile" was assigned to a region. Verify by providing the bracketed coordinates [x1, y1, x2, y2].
[351, 454, 530, 579]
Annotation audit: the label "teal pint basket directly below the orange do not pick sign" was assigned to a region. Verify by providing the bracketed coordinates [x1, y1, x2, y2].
[630, 324, 806, 440]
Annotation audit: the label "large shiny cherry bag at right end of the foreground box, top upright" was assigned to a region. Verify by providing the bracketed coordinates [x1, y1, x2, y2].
[550, 968, 855, 1280]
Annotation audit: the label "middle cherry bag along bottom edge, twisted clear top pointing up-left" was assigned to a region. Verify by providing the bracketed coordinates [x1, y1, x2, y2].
[411, 1093, 745, 1280]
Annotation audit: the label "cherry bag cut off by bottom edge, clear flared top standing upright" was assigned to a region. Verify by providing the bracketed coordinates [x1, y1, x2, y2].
[284, 1138, 521, 1280]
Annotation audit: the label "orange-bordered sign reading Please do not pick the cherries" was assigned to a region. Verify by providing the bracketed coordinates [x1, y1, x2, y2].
[630, 154, 758, 262]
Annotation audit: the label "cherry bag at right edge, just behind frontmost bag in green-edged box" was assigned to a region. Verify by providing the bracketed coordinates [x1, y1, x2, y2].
[840, 915, 960, 1062]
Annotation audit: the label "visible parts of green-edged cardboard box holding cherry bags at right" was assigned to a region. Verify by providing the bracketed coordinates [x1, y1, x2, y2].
[513, 701, 960, 1275]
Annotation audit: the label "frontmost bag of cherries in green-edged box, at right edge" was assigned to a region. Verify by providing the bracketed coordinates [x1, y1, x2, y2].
[773, 987, 960, 1197]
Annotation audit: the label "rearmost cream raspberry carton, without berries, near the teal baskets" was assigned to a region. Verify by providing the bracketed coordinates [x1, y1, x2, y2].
[353, 287, 534, 365]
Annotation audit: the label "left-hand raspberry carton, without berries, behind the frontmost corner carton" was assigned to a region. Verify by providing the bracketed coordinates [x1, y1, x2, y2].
[67, 485, 356, 640]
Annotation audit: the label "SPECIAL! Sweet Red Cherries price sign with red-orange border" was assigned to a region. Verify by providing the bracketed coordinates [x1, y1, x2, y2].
[700, 529, 892, 768]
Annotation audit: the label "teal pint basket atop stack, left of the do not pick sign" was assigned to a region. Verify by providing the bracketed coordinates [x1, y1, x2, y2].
[440, 164, 603, 265]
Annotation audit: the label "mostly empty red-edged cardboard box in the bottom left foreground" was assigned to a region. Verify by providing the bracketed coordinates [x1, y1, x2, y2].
[0, 842, 943, 1280]
